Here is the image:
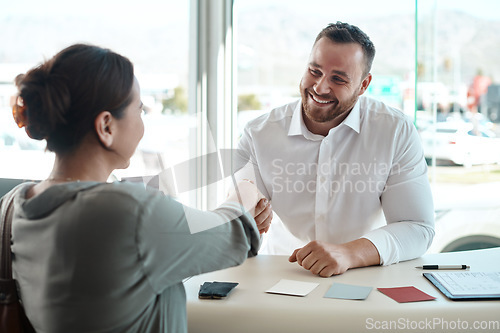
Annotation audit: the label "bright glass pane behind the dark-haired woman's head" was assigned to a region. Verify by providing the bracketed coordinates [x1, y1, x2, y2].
[0, 0, 195, 202]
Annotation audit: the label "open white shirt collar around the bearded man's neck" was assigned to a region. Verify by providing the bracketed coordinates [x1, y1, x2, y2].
[288, 99, 361, 141]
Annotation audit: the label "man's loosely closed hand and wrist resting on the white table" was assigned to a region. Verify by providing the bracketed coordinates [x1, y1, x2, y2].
[288, 238, 380, 277]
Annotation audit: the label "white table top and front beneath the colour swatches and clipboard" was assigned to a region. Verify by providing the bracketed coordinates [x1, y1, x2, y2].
[185, 248, 500, 333]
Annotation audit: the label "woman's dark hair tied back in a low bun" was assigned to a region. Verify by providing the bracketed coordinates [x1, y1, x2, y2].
[16, 44, 134, 154]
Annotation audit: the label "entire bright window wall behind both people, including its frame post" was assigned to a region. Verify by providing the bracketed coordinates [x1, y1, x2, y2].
[0, 0, 500, 252]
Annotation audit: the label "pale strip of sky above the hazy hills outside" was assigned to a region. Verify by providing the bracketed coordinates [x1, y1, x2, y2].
[0, 0, 500, 20]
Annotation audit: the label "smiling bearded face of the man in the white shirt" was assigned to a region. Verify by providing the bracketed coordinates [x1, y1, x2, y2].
[300, 37, 371, 133]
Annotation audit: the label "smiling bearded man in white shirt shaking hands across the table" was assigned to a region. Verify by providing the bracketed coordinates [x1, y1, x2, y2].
[235, 22, 434, 277]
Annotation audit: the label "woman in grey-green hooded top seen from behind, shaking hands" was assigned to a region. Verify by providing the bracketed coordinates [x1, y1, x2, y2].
[2, 44, 270, 333]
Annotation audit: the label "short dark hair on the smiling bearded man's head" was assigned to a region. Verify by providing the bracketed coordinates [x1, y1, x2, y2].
[314, 22, 375, 76]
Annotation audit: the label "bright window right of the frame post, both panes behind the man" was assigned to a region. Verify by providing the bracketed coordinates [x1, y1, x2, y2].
[234, 0, 500, 252]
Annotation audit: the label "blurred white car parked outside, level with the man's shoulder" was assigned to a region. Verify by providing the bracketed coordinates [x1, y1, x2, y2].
[420, 121, 500, 167]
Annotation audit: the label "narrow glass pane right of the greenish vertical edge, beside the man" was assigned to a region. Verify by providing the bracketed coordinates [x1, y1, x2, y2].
[417, 0, 500, 252]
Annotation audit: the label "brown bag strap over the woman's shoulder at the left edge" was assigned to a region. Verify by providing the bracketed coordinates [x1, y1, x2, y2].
[0, 184, 22, 279]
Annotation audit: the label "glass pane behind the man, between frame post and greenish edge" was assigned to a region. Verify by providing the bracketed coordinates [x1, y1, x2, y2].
[234, 0, 415, 255]
